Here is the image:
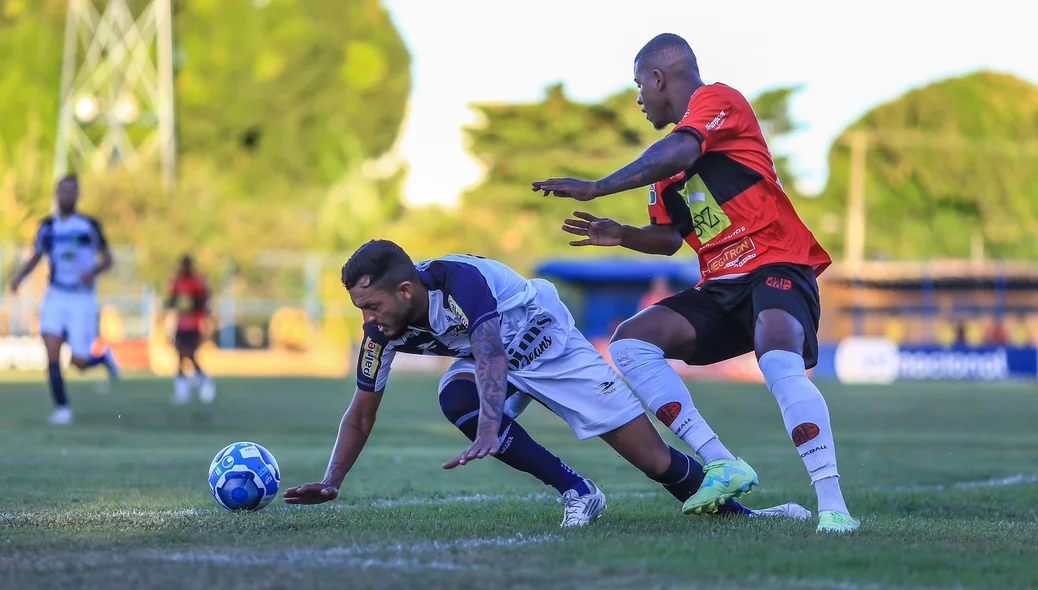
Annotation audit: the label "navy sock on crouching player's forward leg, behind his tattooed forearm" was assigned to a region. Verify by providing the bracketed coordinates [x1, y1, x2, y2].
[440, 380, 591, 495]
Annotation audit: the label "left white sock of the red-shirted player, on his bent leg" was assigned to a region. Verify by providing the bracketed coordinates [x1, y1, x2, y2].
[609, 339, 735, 463]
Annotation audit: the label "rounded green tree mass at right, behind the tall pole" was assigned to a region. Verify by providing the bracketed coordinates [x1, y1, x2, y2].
[811, 72, 1038, 259]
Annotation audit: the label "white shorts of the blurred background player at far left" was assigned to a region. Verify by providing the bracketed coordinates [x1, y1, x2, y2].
[39, 287, 98, 358]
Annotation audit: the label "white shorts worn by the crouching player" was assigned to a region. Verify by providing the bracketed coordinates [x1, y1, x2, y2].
[439, 280, 645, 440]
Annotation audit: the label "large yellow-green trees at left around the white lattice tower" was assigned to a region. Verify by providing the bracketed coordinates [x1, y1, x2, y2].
[0, 0, 411, 283]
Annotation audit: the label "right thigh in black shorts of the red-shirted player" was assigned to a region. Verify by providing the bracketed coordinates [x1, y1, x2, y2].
[753, 264, 821, 369]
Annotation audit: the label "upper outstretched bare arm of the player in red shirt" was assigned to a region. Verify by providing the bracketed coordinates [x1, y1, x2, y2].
[532, 133, 702, 202]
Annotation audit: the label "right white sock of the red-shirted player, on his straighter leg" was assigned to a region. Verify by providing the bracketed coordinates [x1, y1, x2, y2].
[760, 350, 849, 514]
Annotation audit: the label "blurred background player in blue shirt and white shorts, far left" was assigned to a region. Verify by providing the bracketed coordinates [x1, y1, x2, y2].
[10, 176, 119, 425]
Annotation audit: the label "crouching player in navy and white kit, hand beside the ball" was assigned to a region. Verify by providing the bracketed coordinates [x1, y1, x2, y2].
[284, 240, 811, 527]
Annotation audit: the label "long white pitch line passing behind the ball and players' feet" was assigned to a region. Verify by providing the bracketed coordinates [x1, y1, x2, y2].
[0, 474, 1038, 527]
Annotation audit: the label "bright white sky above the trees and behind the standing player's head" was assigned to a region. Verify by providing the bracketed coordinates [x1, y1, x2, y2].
[385, 0, 1038, 205]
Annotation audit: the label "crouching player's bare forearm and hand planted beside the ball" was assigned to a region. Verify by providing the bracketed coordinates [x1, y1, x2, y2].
[283, 390, 382, 504]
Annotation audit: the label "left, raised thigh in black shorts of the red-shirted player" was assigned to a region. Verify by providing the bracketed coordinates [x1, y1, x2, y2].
[647, 286, 754, 365]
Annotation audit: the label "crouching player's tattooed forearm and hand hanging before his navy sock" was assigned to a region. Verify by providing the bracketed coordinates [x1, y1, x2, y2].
[443, 318, 509, 470]
